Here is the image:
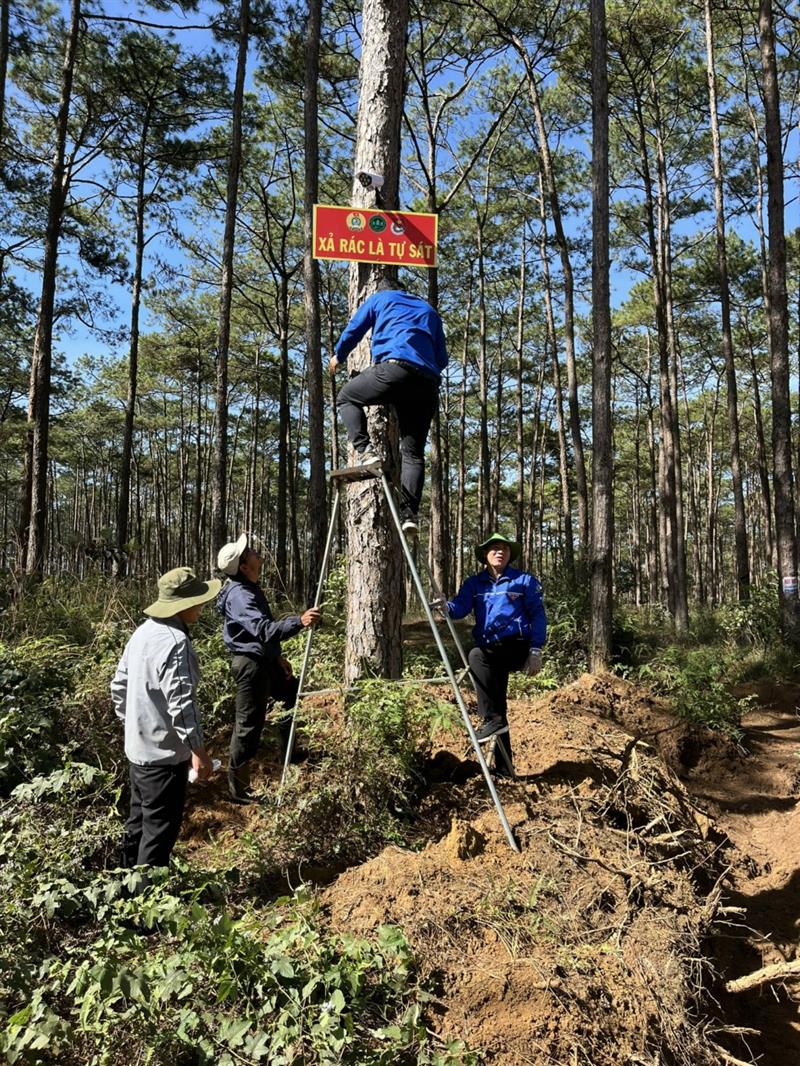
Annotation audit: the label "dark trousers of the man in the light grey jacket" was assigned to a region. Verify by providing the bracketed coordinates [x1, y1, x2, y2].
[123, 760, 189, 869]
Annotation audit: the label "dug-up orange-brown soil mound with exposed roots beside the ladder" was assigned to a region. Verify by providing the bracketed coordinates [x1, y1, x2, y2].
[323, 677, 723, 1066]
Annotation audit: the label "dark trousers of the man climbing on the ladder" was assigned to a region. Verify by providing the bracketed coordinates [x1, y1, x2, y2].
[336, 362, 438, 517]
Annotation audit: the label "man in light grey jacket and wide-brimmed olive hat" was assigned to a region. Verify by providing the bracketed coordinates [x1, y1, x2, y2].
[111, 566, 221, 868]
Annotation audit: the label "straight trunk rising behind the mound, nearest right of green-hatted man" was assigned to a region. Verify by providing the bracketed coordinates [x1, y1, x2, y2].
[590, 0, 613, 672]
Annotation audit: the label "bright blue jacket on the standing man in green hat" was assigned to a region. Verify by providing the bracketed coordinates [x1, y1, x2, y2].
[447, 566, 547, 648]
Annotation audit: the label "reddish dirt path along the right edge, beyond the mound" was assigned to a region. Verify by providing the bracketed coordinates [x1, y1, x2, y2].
[685, 683, 800, 1066]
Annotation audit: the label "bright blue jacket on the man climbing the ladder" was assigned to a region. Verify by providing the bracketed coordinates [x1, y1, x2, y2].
[336, 289, 447, 376]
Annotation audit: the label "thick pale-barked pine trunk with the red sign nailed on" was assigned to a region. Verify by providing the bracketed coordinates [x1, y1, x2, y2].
[345, 0, 409, 683]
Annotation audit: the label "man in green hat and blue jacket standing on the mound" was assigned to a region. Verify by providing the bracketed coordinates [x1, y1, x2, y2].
[444, 533, 547, 774]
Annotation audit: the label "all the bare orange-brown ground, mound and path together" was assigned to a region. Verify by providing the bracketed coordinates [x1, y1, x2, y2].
[187, 675, 800, 1066]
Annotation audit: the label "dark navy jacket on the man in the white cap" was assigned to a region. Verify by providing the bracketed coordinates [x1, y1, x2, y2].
[217, 574, 303, 661]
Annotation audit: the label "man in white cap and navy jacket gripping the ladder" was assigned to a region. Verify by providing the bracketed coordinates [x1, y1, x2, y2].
[217, 533, 322, 804]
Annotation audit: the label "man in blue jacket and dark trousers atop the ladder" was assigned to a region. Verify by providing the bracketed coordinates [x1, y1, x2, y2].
[329, 281, 448, 535]
